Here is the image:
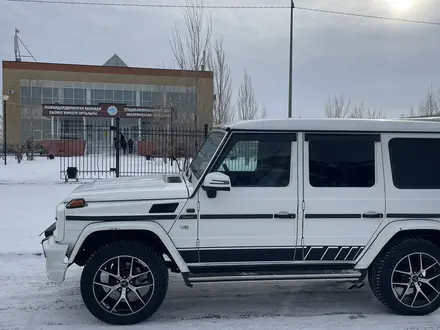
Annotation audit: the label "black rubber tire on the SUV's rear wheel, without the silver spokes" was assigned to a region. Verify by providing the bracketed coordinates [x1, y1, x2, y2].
[370, 238, 440, 315]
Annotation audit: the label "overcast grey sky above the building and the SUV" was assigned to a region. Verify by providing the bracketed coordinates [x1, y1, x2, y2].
[0, 0, 440, 118]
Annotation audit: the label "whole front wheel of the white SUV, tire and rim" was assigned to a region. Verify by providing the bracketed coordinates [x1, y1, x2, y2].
[81, 241, 168, 325]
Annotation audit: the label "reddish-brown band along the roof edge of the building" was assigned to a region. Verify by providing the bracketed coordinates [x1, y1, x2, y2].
[3, 61, 213, 78]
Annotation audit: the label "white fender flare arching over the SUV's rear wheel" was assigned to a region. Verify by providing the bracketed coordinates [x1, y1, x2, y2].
[354, 219, 440, 269]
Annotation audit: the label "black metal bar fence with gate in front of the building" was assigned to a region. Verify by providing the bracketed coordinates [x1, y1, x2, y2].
[56, 118, 208, 181]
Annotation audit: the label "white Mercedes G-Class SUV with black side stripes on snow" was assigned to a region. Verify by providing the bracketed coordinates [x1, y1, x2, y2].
[42, 119, 440, 324]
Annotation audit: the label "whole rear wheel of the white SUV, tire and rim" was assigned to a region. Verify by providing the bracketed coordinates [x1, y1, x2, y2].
[370, 238, 440, 315]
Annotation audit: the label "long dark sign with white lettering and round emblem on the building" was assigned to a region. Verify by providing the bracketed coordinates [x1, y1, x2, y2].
[42, 104, 172, 118]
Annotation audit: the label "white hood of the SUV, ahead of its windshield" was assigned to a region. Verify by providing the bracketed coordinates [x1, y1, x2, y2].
[64, 174, 189, 203]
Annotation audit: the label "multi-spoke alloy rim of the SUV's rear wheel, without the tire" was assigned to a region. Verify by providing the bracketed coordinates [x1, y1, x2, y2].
[391, 252, 440, 308]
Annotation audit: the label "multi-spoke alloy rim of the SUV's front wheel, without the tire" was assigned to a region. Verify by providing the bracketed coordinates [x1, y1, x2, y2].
[93, 255, 154, 316]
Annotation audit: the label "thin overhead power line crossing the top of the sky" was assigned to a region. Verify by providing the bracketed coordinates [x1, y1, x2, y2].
[3, 0, 440, 26]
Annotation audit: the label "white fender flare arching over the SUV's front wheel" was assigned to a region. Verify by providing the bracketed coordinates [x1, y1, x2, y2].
[69, 221, 189, 273]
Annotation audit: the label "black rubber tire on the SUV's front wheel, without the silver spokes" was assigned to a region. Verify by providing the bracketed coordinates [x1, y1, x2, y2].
[80, 241, 168, 325]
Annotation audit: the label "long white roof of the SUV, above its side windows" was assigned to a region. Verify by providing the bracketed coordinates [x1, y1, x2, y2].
[222, 118, 440, 132]
